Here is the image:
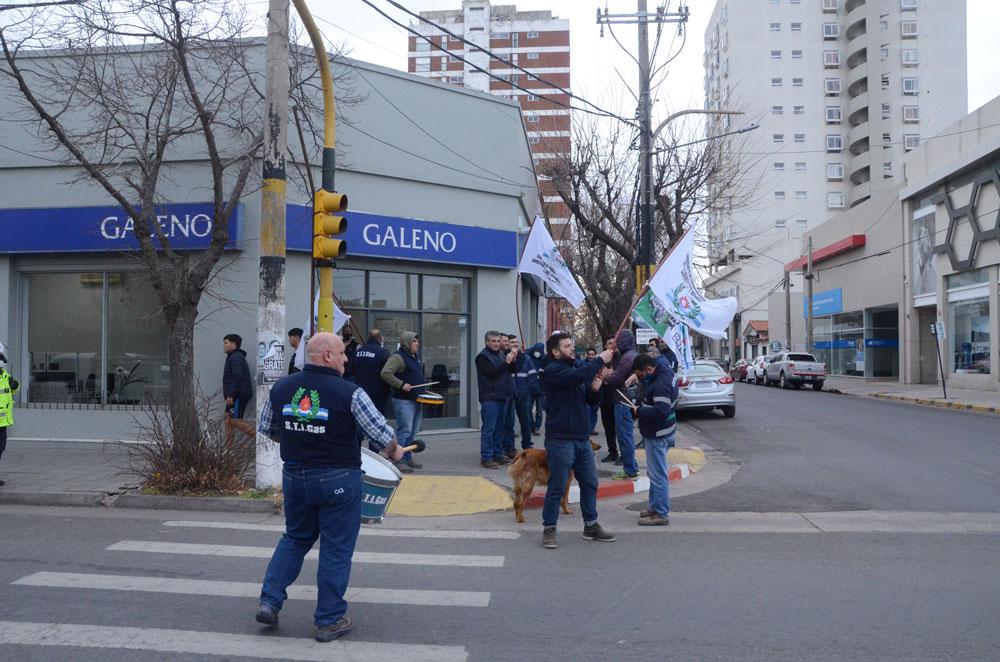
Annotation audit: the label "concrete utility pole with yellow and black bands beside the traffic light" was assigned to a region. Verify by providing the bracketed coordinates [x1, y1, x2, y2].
[254, 0, 288, 488]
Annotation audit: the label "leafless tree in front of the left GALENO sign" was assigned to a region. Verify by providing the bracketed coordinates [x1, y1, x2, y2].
[0, 0, 344, 448]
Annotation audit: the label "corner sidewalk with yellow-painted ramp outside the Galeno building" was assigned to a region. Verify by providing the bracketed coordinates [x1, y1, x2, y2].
[0, 430, 704, 516]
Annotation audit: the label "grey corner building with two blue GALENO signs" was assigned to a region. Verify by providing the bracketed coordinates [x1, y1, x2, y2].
[0, 44, 544, 440]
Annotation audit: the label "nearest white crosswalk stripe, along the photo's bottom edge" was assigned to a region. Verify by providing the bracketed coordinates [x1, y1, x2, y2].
[0, 621, 468, 662]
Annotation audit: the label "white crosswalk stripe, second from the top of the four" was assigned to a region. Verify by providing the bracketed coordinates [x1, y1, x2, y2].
[107, 540, 504, 568]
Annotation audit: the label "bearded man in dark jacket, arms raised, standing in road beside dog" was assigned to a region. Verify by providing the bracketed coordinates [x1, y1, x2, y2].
[542, 331, 615, 549]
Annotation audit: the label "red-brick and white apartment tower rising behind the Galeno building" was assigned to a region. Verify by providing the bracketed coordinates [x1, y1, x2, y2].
[408, 0, 571, 238]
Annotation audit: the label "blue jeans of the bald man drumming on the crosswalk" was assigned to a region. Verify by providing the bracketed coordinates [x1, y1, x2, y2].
[260, 464, 361, 626]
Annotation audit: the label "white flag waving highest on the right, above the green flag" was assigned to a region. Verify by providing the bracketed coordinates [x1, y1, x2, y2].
[649, 230, 736, 342]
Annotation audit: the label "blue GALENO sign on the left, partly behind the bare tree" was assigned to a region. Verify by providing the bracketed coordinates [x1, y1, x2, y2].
[0, 203, 243, 253]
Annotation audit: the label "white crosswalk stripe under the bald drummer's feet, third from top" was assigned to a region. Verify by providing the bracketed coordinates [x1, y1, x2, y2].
[13, 572, 490, 607]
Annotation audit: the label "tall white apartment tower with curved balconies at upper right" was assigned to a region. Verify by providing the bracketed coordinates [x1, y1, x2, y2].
[705, 0, 968, 326]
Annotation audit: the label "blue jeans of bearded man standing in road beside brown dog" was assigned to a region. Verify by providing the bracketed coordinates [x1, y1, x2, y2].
[542, 439, 597, 526]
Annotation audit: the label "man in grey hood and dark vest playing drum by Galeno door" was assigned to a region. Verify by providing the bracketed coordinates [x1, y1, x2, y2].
[379, 331, 427, 473]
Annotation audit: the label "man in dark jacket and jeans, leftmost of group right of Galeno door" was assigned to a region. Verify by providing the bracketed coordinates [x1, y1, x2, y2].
[476, 331, 516, 469]
